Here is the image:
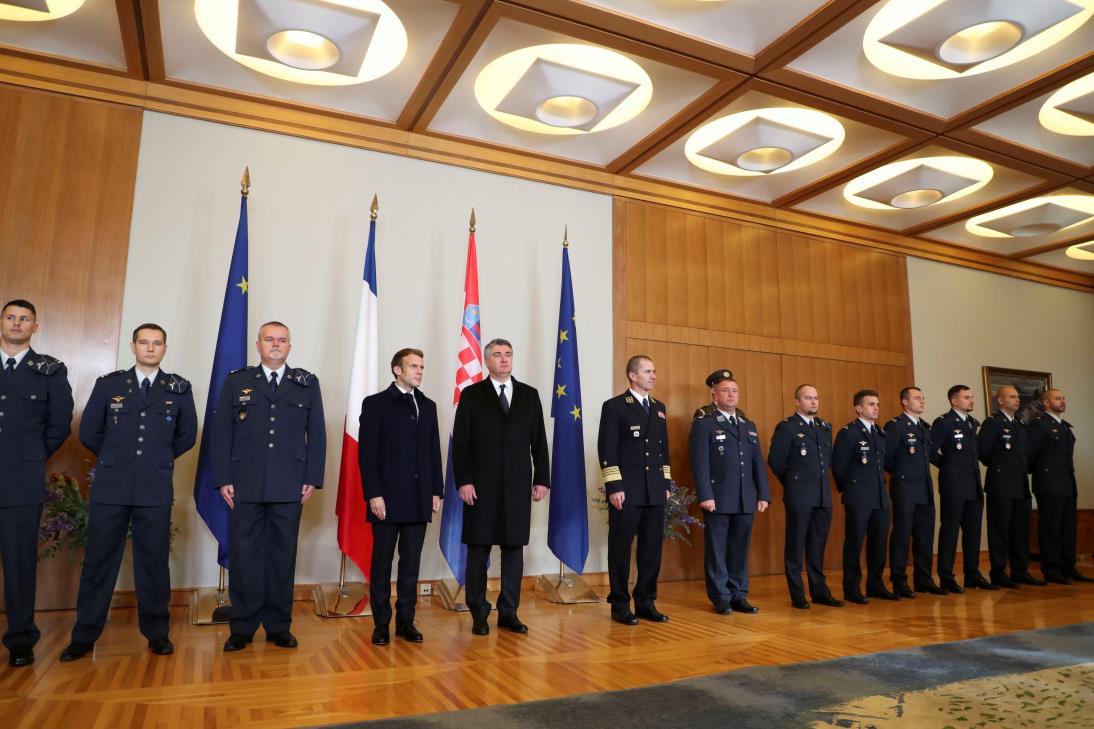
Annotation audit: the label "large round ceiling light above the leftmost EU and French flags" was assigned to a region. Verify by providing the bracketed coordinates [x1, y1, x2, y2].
[194, 0, 407, 86]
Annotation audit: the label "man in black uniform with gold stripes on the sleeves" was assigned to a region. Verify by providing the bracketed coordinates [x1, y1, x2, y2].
[596, 355, 673, 625]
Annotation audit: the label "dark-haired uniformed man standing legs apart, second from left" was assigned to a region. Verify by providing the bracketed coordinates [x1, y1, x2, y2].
[61, 324, 198, 661]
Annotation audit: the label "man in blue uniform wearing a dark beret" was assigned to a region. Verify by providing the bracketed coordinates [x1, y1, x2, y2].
[688, 370, 771, 615]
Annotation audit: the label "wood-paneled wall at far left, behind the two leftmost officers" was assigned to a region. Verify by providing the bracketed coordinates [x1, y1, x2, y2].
[0, 85, 141, 609]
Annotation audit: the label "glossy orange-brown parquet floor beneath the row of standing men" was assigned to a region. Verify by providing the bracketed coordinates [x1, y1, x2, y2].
[0, 564, 1094, 729]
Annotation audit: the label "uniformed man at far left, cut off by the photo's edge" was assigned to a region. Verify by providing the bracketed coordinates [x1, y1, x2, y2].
[0, 299, 72, 667]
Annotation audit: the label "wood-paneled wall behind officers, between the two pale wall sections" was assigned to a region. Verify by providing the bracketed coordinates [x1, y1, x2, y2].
[613, 198, 912, 579]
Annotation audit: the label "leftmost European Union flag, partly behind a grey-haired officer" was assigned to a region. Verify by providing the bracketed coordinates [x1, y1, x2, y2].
[194, 194, 248, 568]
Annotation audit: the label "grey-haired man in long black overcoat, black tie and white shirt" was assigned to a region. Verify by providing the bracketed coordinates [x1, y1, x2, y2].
[452, 339, 550, 635]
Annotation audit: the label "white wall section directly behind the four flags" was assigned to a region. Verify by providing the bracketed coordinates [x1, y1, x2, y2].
[118, 113, 612, 588]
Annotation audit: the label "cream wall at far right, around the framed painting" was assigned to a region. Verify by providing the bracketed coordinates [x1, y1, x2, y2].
[908, 258, 1094, 514]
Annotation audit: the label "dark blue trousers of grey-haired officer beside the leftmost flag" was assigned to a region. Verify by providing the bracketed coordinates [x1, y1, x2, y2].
[228, 501, 303, 635]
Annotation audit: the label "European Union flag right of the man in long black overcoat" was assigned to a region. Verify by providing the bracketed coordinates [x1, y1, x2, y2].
[547, 240, 589, 575]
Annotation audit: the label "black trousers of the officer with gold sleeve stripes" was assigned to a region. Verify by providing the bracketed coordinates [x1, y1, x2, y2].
[608, 500, 665, 611]
